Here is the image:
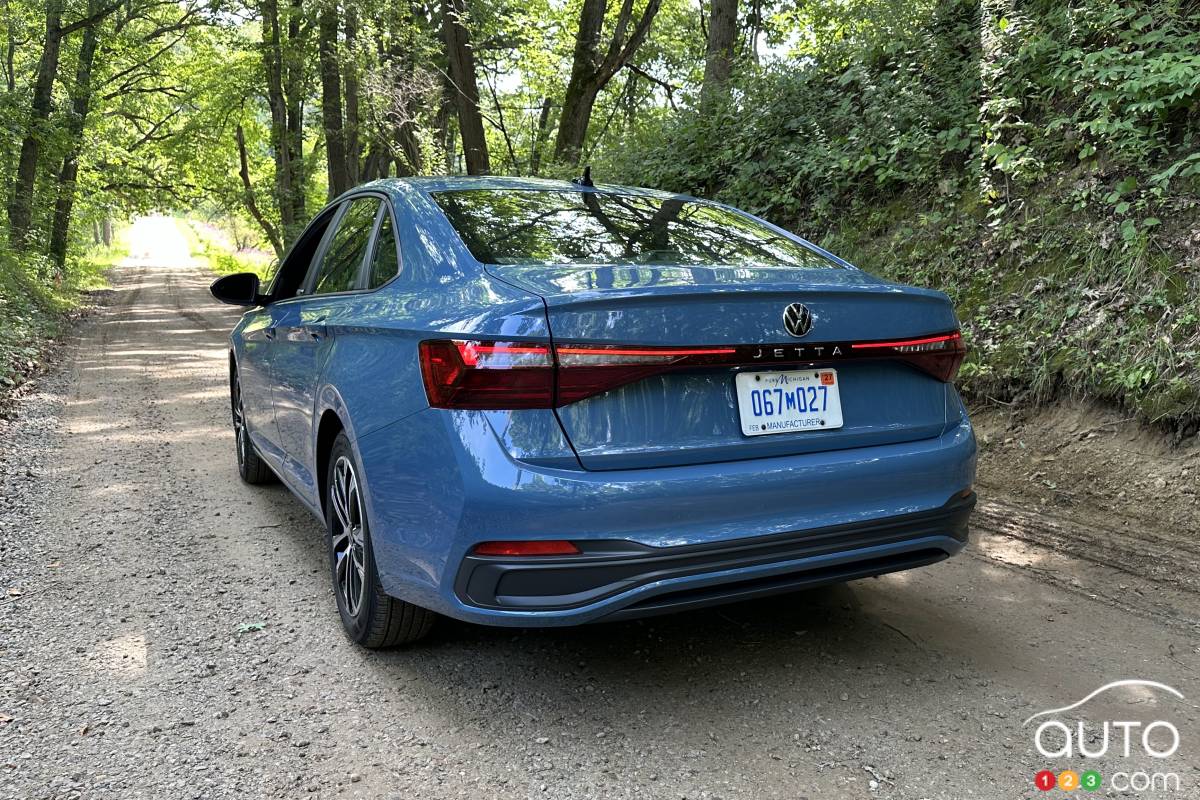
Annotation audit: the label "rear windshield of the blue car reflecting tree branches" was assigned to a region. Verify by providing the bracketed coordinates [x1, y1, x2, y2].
[433, 190, 839, 269]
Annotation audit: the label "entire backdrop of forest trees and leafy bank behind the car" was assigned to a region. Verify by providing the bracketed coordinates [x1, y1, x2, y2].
[0, 0, 1200, 435]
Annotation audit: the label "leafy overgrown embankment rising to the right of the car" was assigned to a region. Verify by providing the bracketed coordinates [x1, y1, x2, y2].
[609, 0, 1200, 426]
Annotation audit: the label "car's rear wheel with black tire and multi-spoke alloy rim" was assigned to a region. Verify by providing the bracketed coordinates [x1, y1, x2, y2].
[325, 433, 436, 650]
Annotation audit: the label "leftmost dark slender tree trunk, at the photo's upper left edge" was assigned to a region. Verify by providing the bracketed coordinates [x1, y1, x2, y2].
[8, 0, 64, 249]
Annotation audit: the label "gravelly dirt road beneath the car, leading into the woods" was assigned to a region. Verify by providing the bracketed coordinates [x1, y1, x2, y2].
[0, 221, 1200, 800]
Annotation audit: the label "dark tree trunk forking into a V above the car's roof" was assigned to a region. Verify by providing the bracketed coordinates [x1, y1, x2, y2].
[554, 0, 662, 164]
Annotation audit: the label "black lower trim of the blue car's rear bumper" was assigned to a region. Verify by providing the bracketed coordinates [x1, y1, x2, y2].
[455, 493, 976, 620]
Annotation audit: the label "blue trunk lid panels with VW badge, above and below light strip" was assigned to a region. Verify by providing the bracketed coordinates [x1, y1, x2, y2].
[487, 265, 958, 470]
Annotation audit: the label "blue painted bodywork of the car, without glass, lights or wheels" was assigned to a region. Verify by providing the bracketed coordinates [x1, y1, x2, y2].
[230, 178, 976, 625]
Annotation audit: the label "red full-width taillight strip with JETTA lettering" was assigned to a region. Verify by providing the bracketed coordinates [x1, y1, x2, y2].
[420, 331, 966, 409]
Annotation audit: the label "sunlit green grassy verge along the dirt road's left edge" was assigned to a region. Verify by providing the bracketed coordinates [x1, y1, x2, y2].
[0, 231, 127, 392]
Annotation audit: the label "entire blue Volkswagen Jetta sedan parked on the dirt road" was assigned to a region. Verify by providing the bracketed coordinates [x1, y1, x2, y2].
[212, 178, 976, 648]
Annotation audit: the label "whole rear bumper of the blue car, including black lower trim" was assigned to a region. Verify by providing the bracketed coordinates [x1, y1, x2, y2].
[358, 409, 976, 626]
